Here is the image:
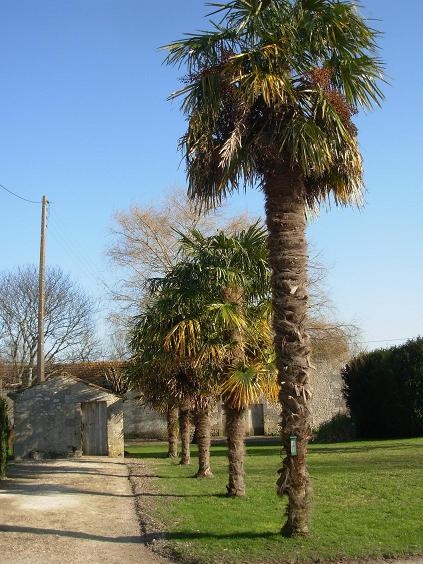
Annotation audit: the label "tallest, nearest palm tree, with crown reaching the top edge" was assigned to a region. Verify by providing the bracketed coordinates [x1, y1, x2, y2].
[166, 0, 383, 536]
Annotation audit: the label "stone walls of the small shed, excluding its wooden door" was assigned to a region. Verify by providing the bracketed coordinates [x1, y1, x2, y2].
[13, 375, 124, 458]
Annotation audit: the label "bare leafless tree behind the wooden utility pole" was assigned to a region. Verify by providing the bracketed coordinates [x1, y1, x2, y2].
[0, 266, 98, 380]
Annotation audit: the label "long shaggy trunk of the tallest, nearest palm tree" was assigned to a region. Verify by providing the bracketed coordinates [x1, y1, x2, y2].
[264, 167, 311, 536]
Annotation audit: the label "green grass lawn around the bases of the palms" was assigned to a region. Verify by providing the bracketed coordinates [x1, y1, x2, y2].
[126, 438, 423, 563]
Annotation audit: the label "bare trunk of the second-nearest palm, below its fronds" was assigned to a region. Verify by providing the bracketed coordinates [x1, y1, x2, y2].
[225, 403, 246, 497]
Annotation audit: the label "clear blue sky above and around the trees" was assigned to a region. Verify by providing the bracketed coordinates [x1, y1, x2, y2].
[0, 0, 423, 348]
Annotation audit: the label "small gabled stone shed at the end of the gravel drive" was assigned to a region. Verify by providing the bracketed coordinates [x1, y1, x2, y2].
[9, 373, 124, 459]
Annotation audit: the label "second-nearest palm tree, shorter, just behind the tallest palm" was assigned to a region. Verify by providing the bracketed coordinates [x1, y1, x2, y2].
[161, 224, 275, 497]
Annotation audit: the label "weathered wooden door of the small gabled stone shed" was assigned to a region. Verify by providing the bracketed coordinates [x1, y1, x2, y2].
[81, 401, 108, 456]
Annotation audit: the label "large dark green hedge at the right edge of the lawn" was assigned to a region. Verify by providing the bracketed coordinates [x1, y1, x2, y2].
[342, 337, 423, 439]
